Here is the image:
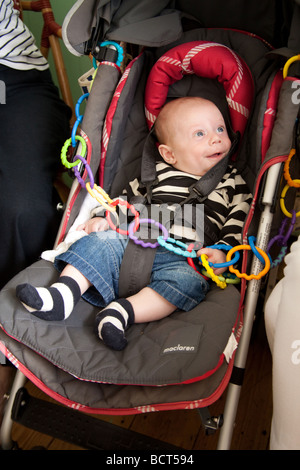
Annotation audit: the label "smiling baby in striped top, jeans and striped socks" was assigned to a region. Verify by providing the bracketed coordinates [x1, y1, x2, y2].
[17, 97, 252, 350]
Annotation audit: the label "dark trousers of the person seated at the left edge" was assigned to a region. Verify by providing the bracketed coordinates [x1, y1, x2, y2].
[0, 65, 70, 288]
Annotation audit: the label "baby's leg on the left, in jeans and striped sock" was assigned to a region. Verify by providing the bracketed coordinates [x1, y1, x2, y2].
[16, 231, 126, 321]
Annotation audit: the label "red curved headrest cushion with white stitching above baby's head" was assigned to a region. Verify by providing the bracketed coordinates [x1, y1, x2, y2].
[145, 41, 254, 135]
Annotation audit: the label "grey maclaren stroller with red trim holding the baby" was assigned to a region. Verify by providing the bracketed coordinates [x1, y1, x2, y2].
[0, 0, 300, 450]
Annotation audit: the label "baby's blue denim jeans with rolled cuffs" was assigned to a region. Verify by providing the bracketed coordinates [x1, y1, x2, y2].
[55, 230, 209, 311]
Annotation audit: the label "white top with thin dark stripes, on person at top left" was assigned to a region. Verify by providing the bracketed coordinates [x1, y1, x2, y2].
[0, 0, 49, 70]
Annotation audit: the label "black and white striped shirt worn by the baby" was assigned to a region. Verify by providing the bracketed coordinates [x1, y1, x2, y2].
[127, 162, 252, 246]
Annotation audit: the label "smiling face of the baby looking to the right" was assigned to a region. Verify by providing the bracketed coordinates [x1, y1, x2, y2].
[162, 99, 231, 176]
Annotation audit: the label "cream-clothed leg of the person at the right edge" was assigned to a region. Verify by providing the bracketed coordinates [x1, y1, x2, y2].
[265, 237, 300, 450]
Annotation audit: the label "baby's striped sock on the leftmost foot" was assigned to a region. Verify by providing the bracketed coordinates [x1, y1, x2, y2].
[16, 276, 81, 321]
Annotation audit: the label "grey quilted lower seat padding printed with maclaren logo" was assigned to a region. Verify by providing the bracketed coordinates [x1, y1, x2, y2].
[0, 260, 240, 386]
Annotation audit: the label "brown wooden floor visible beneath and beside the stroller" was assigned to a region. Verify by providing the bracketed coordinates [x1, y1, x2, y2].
[8, 312, 272, 450]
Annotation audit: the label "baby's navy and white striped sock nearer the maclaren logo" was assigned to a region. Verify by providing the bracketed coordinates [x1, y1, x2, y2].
[96, 299, 134, 351]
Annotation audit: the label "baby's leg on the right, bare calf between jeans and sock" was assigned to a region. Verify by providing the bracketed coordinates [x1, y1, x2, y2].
[96, 249, 209, 350]
